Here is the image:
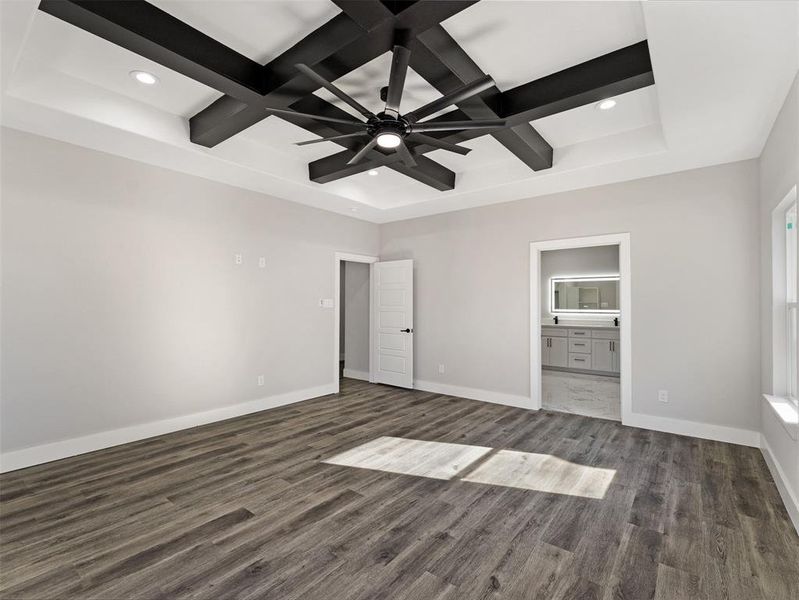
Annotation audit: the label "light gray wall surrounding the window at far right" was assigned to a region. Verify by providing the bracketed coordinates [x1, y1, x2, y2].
[759, 72, 799, 528]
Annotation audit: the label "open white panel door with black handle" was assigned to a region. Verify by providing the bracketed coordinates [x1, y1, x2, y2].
[374, 260, 413, 388]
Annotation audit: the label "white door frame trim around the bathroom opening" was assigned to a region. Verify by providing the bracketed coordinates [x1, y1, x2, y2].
[529, 233, 633, 424]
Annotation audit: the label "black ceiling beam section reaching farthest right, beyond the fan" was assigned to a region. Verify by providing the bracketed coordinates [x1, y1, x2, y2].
[500, 40, 655, 124]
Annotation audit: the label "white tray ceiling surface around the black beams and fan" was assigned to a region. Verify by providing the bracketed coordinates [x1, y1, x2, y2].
[0, 0, 799, 222]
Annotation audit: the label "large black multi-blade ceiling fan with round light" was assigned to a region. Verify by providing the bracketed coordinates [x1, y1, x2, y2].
[266, 34, 505, 167]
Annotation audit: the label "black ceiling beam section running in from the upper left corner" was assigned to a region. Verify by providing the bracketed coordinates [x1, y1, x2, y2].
[39, 0, 266, 102]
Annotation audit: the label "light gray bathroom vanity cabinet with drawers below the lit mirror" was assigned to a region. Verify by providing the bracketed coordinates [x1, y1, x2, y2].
[541, 324, 620, 375]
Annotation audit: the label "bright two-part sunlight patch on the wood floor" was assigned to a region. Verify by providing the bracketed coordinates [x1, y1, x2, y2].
[322, 436, 616, 498]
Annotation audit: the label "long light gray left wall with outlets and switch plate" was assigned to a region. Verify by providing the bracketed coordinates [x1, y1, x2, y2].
[0, 129, 379, 451]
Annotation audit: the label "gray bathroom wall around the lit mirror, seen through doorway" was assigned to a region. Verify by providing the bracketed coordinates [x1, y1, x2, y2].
[541, 246, 619, 323]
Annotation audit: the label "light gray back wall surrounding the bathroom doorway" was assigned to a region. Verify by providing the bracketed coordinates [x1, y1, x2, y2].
[381, 161, 760, 429]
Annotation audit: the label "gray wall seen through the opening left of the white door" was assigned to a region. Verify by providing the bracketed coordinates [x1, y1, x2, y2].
[342, 262, 369, 381]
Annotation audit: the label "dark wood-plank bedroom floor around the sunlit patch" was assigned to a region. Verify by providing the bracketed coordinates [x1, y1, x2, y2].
[0, 380, 799, 600]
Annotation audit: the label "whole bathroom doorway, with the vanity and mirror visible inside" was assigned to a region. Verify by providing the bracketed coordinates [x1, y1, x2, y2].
[530, 234, 632, 423]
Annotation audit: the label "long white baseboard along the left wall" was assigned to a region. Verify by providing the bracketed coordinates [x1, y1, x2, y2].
[0, 383, 335, 473]
